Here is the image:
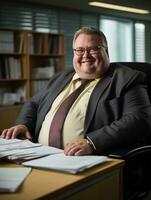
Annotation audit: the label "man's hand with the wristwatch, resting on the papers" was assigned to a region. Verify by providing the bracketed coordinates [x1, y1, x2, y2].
[64, 139, 93, 156]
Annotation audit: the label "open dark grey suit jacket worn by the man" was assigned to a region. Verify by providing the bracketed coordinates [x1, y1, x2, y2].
[16, 63, 151, 154]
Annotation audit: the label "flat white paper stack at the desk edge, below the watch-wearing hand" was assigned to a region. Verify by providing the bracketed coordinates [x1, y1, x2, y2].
[22, 153, 111, 174]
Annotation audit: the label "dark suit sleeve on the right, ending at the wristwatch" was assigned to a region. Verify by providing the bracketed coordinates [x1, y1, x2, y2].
[87, 73, 151, 153]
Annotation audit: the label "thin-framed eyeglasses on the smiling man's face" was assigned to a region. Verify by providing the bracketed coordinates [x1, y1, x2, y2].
[73, 46, 105, 56]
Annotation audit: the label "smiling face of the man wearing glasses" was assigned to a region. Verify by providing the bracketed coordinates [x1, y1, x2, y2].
[73, 34, 109, 79]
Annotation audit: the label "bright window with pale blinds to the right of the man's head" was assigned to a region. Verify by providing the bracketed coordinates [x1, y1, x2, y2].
[100, 17, 145, 62]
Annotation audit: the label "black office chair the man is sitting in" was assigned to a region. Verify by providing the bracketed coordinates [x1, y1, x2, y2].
[114, 62, 151, 200]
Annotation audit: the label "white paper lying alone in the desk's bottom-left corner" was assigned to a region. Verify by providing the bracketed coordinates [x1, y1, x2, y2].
[0, 167, 31, 192]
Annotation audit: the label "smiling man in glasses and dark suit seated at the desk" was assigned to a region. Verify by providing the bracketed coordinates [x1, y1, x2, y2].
[1, 27, 151, 155]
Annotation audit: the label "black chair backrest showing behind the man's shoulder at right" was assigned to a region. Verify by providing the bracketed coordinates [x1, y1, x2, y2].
[116, 62, 151, 101]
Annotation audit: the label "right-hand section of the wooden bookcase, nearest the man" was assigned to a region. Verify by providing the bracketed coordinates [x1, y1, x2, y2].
[28, 32, 64, 96]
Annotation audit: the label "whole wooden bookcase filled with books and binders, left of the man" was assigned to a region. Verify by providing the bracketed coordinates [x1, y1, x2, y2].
[0, 29, 65, 132]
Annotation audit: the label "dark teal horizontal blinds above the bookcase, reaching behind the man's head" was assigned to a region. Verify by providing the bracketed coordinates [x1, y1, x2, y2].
[0, 1, 98, 68]
